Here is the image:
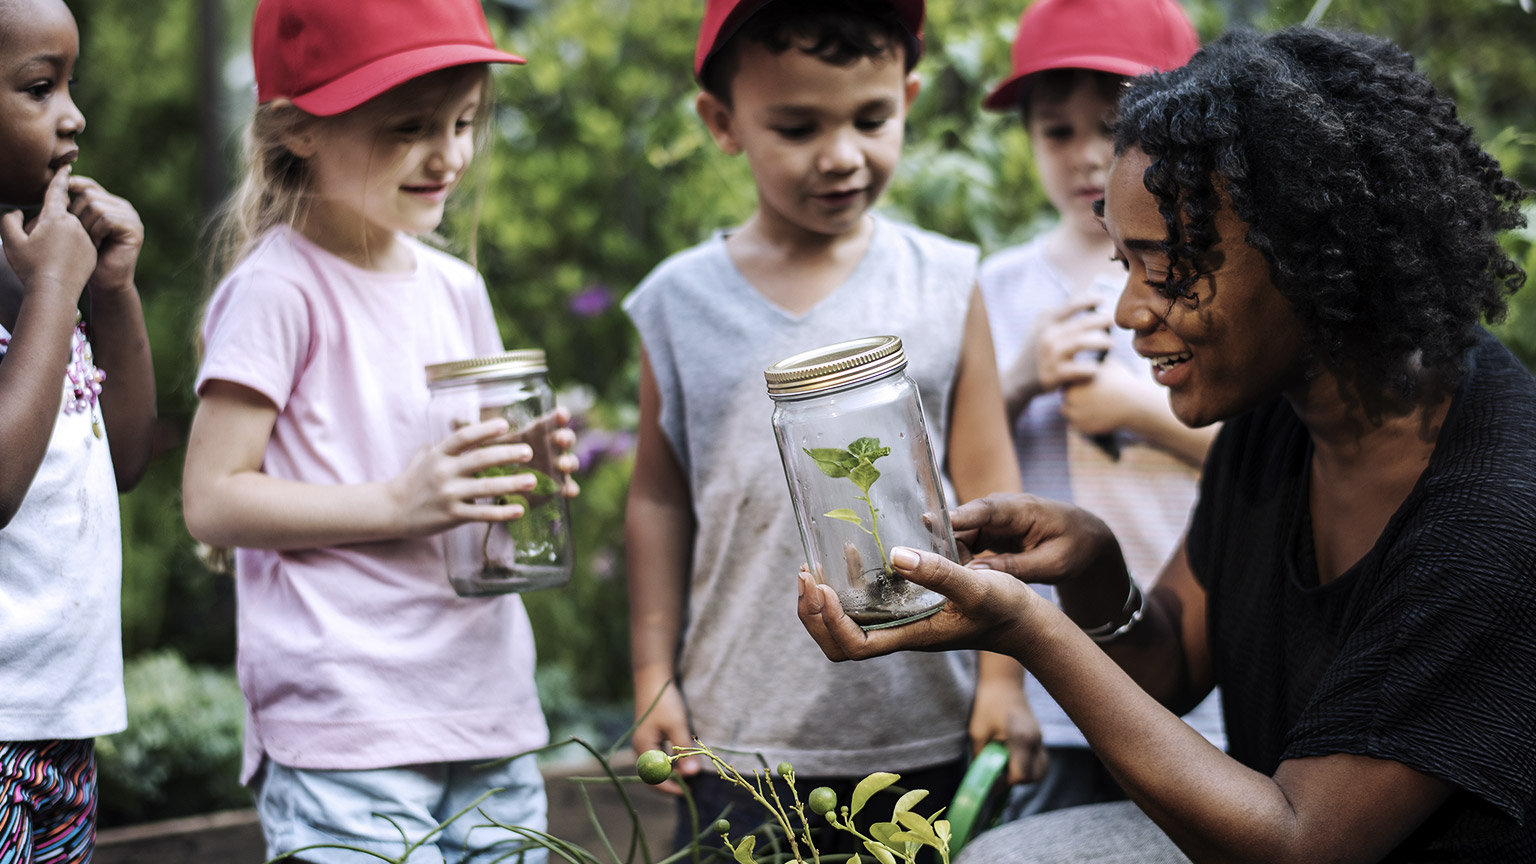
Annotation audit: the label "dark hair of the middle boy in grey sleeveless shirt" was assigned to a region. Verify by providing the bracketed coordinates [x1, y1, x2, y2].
[699, 0, 922, 105]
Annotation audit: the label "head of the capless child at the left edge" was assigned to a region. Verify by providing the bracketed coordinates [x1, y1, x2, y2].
[0, 0, 86, 208]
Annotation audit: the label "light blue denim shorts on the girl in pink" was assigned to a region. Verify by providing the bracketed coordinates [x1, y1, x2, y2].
[255, 755, 548, 864]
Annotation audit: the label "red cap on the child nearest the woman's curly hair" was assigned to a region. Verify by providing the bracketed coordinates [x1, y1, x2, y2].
[982, 0, 1200, 111]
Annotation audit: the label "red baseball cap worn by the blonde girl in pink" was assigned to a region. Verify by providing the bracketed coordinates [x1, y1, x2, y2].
[250, 0, 524, 117]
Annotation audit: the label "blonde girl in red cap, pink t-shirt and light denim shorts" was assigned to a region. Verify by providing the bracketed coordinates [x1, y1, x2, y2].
[183, 0, 574, 862]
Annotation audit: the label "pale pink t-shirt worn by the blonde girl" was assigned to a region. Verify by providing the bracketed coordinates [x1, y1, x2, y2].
[197, 228, 548, 781]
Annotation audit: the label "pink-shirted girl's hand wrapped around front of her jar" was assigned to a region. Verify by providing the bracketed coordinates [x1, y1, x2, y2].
[386, 418, 538, 537]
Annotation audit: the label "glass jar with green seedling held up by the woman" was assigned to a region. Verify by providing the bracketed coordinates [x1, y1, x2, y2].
[763, 337, 958, 630]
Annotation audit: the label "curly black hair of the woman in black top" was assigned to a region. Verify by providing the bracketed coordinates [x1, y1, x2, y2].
[1115, 28, 1527, 397]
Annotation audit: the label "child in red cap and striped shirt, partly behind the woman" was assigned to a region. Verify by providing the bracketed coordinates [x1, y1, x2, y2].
[980, 0, 1226, 818]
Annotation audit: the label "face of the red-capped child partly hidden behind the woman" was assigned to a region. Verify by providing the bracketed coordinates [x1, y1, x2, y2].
[1029, 75, 1115, 235]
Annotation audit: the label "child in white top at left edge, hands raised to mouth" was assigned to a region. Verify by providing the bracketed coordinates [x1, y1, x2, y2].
[0, 0, 155, 861]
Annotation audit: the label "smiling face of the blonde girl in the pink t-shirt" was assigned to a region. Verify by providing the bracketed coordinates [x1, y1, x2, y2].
[289, 68, 484, 238]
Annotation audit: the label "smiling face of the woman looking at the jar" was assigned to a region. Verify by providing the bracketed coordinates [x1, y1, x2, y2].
[1104, 149, 1307, 427]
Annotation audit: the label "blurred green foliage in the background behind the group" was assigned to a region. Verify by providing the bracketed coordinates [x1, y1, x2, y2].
[42, 0, 1536, 821]
